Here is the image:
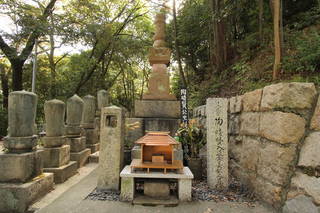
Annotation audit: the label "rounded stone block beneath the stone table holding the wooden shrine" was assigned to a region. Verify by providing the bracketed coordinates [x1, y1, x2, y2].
[143, 180, 170, 199]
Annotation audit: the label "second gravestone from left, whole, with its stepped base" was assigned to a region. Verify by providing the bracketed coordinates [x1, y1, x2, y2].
[43, 99, 77, 183]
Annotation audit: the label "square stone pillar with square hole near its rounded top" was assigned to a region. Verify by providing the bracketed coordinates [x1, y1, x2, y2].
[97, 106, 125, 190]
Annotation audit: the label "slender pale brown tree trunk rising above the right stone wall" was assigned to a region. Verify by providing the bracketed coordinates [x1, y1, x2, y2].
[272, 0, 281, 80]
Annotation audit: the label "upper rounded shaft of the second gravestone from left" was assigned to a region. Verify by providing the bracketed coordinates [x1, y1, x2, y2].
[44, 99, 65, 137]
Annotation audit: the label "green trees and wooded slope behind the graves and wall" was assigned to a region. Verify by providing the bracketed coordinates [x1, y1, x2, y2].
[0, 0, 320, 135]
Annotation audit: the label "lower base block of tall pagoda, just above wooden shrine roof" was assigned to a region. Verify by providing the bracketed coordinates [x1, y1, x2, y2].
[144, 118, 180, 136]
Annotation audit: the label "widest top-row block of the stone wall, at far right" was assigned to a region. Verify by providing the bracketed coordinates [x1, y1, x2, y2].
[261, 82, 317, 110]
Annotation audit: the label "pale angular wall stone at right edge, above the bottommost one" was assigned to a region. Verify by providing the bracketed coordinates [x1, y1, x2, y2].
[291, 172, 320, 205]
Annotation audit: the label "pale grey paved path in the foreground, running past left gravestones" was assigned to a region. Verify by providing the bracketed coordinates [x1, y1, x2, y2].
[33, 164, 274, 213]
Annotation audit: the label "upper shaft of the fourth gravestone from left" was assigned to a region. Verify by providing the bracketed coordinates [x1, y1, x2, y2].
[81, 95, 96, 129]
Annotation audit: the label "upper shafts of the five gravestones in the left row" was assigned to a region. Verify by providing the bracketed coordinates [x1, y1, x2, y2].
[4, 90, 108, 153]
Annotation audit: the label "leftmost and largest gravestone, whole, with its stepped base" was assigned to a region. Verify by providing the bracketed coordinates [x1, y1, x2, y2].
[0, 91, 53, 213]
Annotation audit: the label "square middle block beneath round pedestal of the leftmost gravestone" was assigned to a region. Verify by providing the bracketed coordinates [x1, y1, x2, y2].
[0, 150, 43, 183]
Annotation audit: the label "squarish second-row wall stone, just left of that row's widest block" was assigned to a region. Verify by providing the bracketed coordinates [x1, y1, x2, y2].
[240, 112, 260, 135]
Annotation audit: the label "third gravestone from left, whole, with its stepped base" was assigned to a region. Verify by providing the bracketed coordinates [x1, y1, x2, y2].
[66, 95, 91, 168]
